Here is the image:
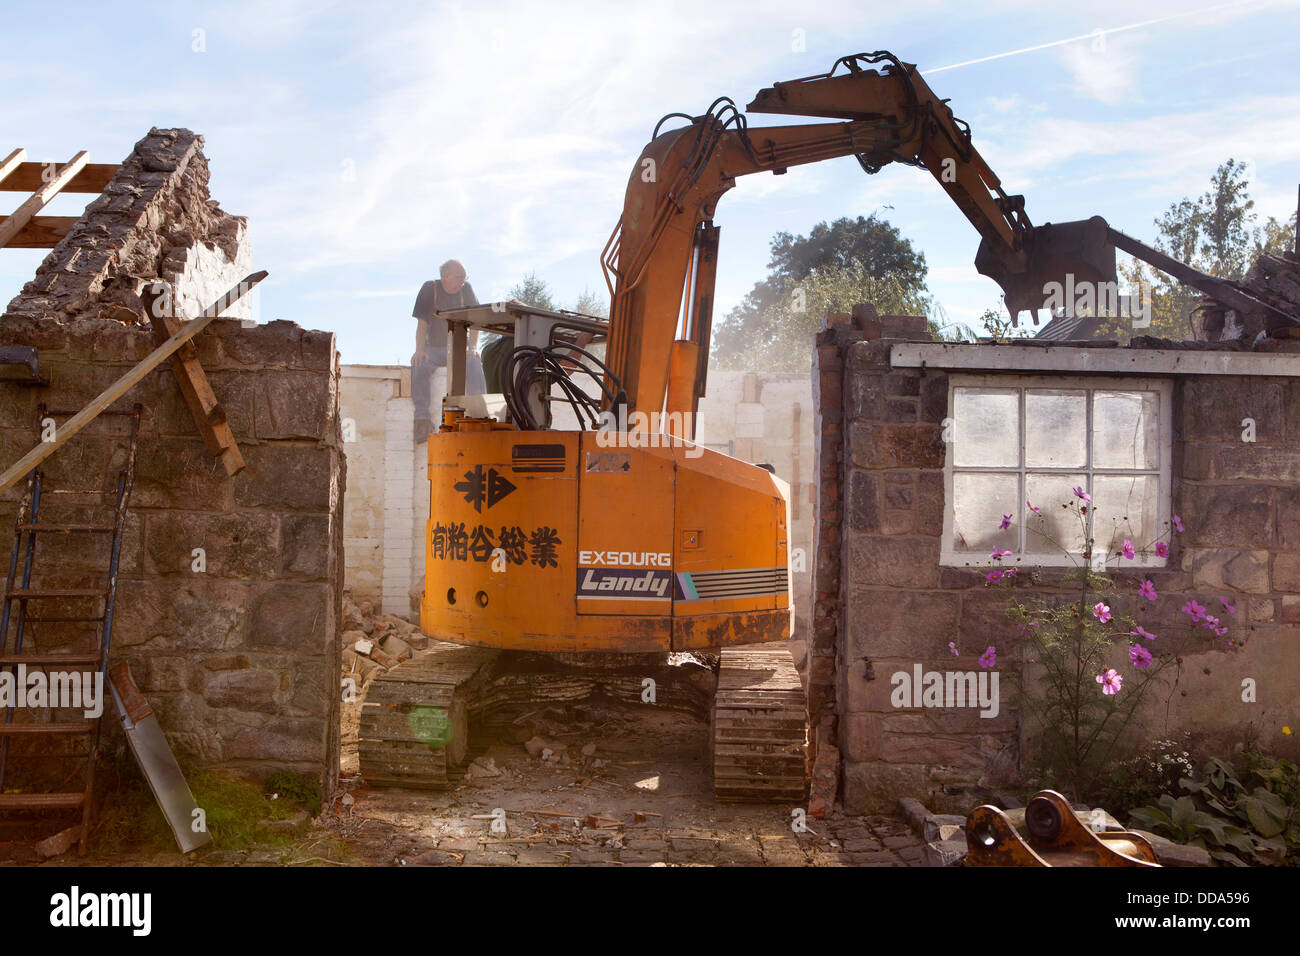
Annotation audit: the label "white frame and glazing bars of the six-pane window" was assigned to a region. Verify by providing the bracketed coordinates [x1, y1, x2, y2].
[939, 373, 1174, 570]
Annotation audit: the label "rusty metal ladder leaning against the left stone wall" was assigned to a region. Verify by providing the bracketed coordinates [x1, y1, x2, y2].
[0, 403, 142, 856]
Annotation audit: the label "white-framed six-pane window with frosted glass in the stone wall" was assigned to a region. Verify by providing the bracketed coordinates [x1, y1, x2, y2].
[941, 375, 1173, 567]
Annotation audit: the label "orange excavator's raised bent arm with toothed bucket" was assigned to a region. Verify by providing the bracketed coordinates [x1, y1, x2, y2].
[602, 52, 1115, 438]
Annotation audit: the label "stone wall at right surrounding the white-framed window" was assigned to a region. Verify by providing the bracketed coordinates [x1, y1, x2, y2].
[810, 316, 1300, 813]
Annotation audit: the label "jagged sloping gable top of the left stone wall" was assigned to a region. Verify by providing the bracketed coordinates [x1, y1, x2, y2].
[7, 129, 256, 324]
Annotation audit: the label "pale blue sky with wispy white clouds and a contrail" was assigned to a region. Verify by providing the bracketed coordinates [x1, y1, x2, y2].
[0, 0, 1300, 364]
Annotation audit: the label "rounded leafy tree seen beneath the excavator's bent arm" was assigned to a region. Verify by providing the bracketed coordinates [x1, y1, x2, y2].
[714, 213, 935, 371]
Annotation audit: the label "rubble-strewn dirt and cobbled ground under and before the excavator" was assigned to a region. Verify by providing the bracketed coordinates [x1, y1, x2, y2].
[10, 702, 920, 866]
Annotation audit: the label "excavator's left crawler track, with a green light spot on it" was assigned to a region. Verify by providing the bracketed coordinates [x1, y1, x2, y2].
[358, 641, 501, 790]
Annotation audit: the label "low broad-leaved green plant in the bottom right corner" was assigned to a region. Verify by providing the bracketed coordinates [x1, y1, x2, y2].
[1128, 752, 1300, 866]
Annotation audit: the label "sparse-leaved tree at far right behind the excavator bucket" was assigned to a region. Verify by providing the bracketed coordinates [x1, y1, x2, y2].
[1119, 159, 1295, 339]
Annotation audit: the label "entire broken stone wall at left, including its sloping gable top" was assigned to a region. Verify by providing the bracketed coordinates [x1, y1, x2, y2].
[0, 129, 346, 791]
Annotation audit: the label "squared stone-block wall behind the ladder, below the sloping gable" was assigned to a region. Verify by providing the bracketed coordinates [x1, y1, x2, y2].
[0, 316, 345, 786]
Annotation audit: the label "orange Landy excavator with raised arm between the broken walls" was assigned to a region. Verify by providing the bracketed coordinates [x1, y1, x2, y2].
[360, 52, 1164, 803]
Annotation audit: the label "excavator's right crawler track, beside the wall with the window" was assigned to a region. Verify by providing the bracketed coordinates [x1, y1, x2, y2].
[710, 645, 809, 804]
